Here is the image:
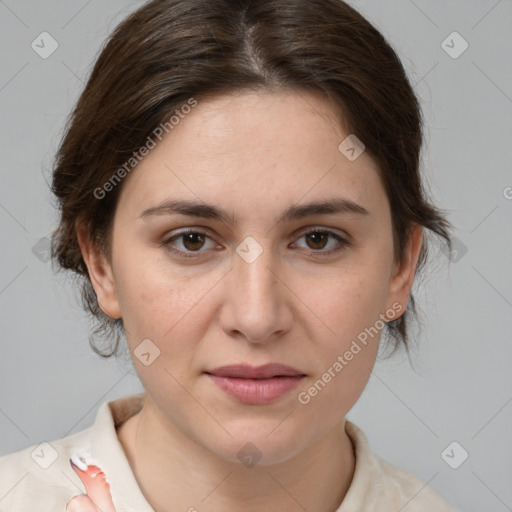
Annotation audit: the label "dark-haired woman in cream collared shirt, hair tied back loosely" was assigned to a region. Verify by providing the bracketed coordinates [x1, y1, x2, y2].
[0, 0, 454, 512]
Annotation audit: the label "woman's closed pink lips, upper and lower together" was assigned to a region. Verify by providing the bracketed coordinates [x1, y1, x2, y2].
[205, 363, 305, 405]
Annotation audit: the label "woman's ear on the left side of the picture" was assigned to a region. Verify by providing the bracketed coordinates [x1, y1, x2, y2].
[76, 224, 122, 318]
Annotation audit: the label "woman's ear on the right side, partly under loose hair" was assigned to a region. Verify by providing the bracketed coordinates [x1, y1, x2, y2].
[387, 224, 423, 320]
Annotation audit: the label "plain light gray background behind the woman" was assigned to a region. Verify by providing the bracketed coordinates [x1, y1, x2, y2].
[0, 0, 512, 512]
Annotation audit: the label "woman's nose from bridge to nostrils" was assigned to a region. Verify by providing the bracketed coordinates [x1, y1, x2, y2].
[221, 239, 293, 344]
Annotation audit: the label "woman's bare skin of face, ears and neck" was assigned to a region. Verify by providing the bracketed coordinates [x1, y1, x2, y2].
[78, 92, 422, 512]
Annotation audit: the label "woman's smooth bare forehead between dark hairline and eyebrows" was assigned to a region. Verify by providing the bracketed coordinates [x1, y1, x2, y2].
[120, 92, 386, 220]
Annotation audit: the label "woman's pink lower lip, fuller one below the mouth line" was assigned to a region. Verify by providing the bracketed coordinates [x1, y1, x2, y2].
[207, 374, 303, 405]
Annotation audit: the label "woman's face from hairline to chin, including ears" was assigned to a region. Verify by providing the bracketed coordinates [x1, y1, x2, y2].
[83, 92, 419, 464]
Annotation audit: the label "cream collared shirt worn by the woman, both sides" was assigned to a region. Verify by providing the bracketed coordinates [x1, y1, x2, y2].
[0, 393, 456, 512]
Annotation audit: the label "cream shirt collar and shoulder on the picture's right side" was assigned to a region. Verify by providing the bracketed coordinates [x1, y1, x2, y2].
[339, 421, 457, 512]
